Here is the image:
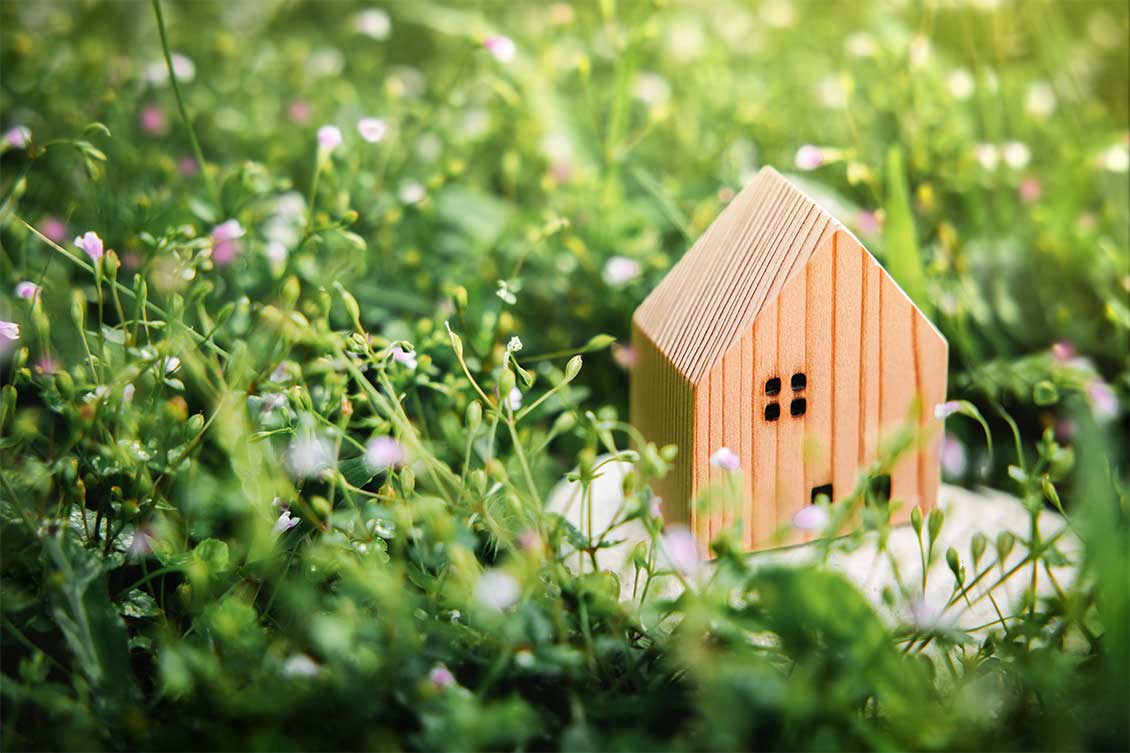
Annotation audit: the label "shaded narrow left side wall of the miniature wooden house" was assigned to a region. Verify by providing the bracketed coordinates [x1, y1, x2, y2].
[629, 323, 695, 526]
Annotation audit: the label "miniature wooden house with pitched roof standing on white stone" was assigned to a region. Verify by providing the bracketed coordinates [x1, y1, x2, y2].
[632, 167, 947, 548]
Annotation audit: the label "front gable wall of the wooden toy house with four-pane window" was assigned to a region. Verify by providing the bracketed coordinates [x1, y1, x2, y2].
[693, 228, 947, 548]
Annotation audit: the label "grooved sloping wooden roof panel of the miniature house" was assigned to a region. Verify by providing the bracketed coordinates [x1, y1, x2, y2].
[634, 167, 846, 383]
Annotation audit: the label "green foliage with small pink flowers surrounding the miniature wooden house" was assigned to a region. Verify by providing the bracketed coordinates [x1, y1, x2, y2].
[0, 0, 1130, 750]
